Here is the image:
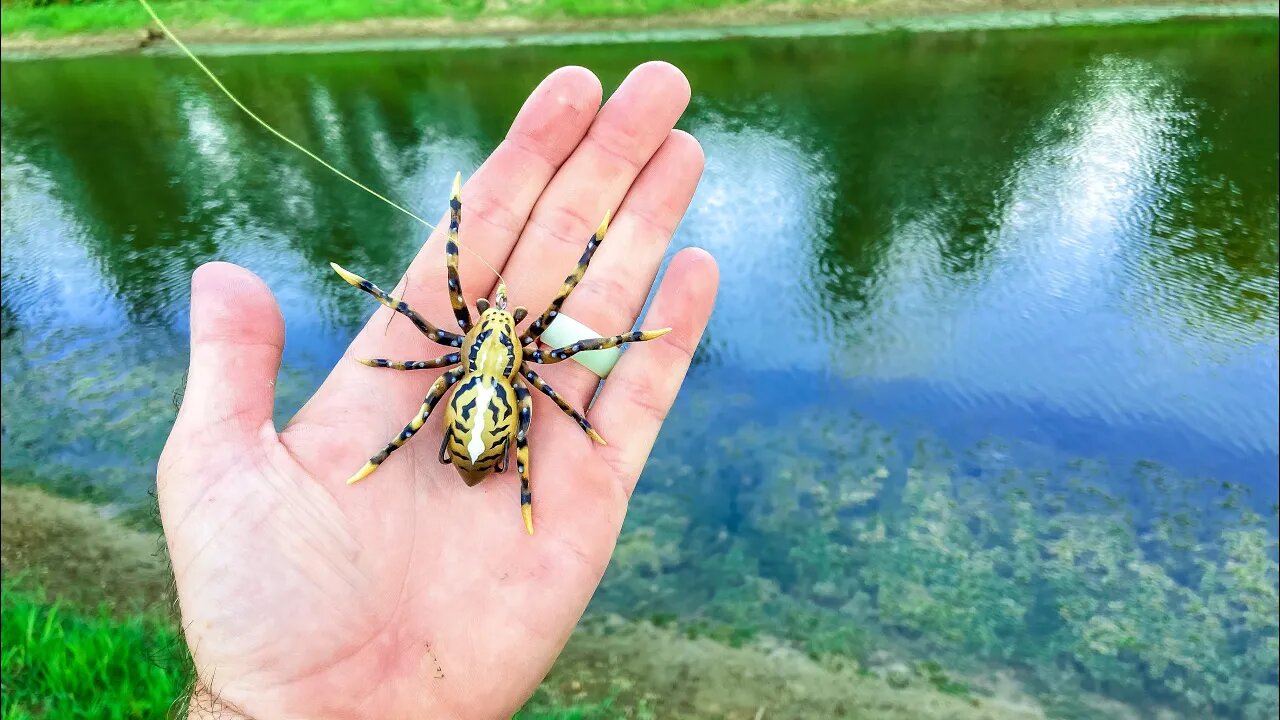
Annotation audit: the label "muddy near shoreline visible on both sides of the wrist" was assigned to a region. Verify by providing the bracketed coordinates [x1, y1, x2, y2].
[0, 482, 1044, 720]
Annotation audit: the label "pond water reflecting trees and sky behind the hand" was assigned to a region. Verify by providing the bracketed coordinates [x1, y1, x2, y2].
[0, 18, 1280, 716]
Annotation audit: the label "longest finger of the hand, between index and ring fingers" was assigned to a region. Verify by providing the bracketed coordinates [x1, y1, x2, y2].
[503, 63, 690, 332]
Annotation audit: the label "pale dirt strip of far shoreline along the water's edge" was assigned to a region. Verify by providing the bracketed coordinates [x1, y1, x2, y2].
[0, 0, 1280, 61]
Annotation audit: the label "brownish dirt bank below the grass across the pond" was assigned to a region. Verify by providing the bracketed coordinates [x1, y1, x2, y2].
[3, 0, 1277, 59]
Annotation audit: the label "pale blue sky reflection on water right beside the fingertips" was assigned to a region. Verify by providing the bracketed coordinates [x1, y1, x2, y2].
[678, 109, 842, 372]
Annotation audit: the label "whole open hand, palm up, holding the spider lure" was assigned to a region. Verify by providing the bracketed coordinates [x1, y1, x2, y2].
[157, 63, 716, 720]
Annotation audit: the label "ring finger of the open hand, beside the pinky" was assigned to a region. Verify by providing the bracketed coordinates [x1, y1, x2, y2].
[517, 131, 703, 407]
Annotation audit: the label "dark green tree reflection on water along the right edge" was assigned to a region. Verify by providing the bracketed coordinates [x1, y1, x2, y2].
[1142, 28, 1280, 343]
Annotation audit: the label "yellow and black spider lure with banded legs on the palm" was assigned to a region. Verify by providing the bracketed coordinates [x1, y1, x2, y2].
[330, 173, 671, 534]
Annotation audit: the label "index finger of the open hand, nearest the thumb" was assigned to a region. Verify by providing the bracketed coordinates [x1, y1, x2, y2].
[357, 67, 603, 354]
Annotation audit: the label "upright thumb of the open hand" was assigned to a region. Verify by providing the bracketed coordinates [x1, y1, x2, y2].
[177, 257, 284, 439]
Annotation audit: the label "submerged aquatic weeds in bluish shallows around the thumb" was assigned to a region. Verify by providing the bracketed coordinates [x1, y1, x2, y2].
[0, 327, 314, 509]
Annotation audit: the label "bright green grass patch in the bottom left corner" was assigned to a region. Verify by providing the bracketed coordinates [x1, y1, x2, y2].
[0, 578, 191, 720]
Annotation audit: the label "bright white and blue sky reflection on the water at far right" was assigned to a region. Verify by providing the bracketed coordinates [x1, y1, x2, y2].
[933, 56, 1276, 452]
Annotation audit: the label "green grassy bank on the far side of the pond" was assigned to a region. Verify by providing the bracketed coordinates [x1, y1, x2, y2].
[0, 0, 1256, 51]
